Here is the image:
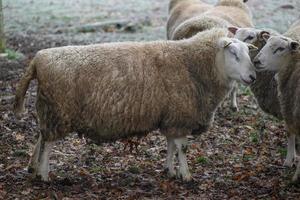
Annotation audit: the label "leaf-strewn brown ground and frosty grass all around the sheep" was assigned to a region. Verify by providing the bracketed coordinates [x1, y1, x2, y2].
[0, 0, 300, 199]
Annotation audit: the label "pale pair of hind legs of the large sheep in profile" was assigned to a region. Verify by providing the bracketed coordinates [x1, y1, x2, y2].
[28, 134, 54, 181]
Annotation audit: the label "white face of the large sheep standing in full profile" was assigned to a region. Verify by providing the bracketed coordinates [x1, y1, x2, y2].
[216, 38, 256, 85]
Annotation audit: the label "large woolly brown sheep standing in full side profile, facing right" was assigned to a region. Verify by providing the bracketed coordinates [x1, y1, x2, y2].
[14, 28, 255, 181]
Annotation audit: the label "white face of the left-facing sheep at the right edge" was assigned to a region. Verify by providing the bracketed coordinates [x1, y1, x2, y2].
[254, 36, 300, 71]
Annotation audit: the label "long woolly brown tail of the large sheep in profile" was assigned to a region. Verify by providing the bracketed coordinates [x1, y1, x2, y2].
[14, 59, 36, 118]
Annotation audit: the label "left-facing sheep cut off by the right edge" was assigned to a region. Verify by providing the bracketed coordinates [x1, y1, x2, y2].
[254, 21, 300, 181]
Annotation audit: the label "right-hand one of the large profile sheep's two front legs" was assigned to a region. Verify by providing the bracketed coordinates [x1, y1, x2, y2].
[174, 136, 192, 181]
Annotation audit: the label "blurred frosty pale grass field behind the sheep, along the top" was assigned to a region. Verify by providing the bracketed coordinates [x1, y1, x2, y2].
[3, 0, 300, 54]
